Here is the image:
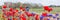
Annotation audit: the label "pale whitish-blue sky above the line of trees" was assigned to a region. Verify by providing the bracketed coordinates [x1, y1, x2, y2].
[0, 0, 60, 6]
